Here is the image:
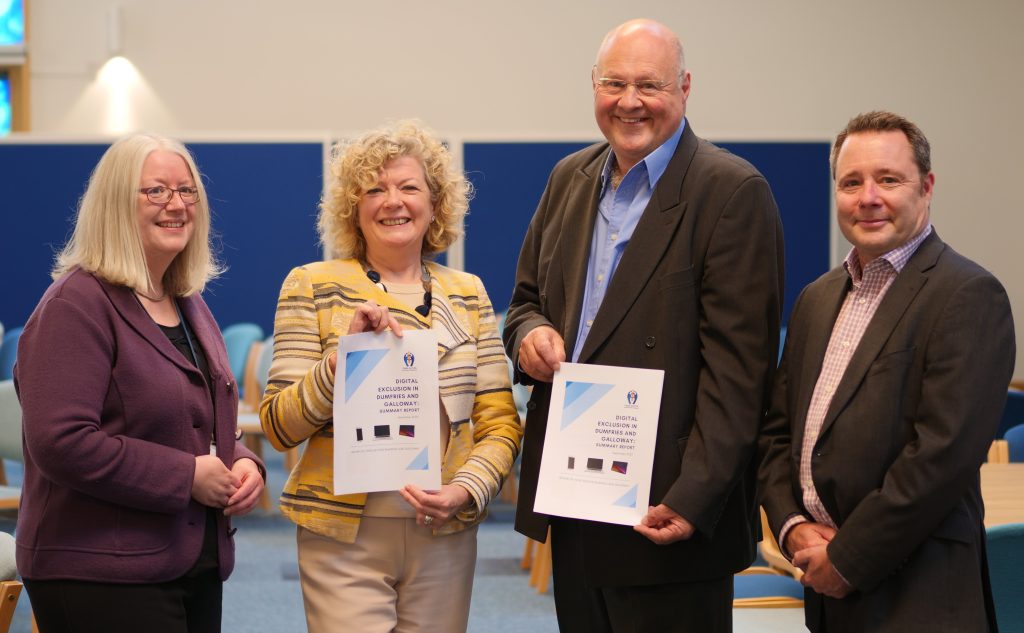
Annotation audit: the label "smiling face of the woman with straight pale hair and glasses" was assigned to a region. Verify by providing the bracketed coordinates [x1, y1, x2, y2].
[136, 150, 196, 282]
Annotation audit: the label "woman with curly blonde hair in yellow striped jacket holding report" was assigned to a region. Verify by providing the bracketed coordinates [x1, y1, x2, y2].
[260, 121, 522, 633]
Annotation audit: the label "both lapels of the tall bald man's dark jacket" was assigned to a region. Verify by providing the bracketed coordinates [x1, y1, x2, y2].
[566, 125, 697, 363]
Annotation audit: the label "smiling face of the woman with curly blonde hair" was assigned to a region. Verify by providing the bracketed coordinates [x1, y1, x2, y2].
[356, 156, 434, 262]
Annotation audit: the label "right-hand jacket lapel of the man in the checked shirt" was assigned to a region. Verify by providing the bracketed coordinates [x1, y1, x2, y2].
[819, 230, 945, 437]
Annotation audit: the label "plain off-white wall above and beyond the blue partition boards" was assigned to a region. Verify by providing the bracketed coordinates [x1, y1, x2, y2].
[19, 0, 1024, 377]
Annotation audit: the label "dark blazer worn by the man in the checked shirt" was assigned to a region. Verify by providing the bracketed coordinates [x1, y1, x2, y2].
[760, 233, 1015, 633]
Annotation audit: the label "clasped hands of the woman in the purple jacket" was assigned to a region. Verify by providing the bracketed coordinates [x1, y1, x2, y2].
[191, 455, 263, 516]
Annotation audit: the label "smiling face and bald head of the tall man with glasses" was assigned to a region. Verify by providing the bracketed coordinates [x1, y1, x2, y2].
[594, 22, 690, 173]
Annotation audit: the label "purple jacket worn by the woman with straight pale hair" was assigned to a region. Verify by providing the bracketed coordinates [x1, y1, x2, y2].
[14, 269, 263, 583]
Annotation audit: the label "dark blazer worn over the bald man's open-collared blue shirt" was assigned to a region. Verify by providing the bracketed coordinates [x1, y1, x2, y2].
[504, 125, 783, 586]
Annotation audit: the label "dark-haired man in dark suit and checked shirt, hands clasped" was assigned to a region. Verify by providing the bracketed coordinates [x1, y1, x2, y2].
[760, 112, 1015, 633]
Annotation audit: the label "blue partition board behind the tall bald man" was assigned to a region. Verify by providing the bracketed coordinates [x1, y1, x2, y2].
[463, 142, 829, 323]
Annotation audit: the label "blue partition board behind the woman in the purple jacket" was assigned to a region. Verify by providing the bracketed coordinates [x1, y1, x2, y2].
[0, 142, 323, 333]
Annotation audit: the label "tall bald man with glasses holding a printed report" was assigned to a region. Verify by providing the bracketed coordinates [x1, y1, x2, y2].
[504, 19, 783, 633]
